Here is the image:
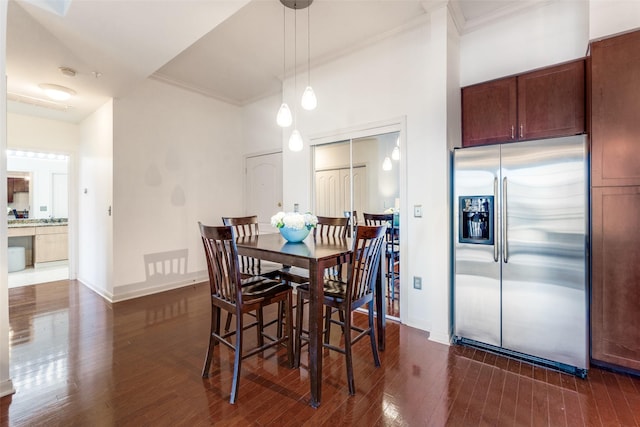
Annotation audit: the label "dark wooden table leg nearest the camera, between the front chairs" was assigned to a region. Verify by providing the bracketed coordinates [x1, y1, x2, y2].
[309, 263, 324, 408]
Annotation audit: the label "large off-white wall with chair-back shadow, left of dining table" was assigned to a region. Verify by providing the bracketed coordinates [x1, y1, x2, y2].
[113, 79, 244, 301]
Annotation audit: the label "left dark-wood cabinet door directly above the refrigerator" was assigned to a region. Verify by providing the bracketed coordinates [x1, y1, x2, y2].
[462, 77, 517, 147]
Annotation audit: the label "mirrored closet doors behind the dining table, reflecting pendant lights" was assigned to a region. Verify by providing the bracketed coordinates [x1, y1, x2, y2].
[313, 131, 402, 319]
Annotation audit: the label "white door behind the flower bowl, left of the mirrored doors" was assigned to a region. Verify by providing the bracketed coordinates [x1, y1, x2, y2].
[244, 152, 282, 231]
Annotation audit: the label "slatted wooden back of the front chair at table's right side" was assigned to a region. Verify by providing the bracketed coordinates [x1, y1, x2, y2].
[347, 225, 387, 302]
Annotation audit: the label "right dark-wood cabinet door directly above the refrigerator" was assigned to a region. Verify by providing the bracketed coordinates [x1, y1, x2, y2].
[517, 59, 585, 140]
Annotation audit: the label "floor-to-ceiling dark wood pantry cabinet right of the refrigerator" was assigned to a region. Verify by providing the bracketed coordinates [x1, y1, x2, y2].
[589, 31, 640, 373]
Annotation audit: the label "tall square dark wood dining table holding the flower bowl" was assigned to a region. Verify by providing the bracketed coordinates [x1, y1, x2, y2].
[236, 233, 386, 408]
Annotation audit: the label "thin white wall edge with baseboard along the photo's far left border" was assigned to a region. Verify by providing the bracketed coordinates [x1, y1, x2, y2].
[0, 1, 15, 397]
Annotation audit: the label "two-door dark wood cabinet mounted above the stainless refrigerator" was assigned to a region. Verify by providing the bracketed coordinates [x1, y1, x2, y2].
[462, 59, 585, 147]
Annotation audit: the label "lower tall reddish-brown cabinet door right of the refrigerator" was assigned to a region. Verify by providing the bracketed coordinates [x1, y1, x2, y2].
[591, 187, 640, 370]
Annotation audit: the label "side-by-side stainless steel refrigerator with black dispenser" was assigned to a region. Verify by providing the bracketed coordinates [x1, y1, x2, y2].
[453, 135, 588, 376]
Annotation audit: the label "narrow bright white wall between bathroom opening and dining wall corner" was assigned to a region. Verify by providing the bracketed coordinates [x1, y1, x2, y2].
[75, 101, 113, 299]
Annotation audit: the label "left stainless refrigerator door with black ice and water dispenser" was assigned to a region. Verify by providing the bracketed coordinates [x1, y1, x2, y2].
[453, 145, 501, 346]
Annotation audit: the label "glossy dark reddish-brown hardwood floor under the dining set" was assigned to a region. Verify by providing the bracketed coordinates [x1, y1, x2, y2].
[0, 281, 640, 426]
